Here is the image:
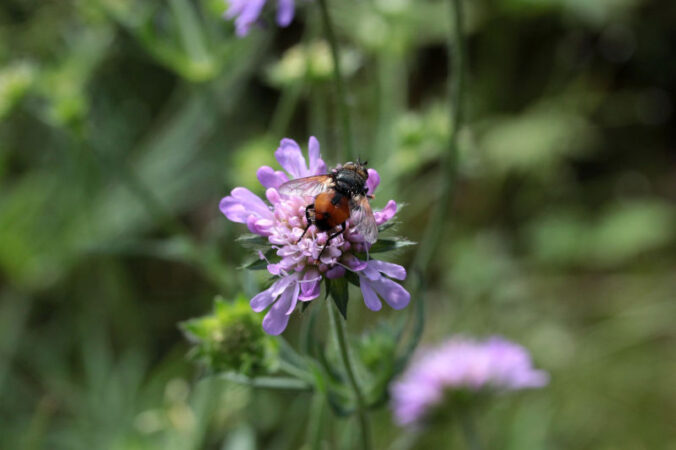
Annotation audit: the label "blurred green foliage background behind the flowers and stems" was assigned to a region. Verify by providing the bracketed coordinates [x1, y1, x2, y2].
[0, 0, 676, 449]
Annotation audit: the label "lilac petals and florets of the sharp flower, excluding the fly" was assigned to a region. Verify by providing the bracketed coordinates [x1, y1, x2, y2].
[220, 137, 411, 335]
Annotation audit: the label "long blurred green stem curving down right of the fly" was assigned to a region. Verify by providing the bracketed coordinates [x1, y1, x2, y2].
[414, 0, 465, 274]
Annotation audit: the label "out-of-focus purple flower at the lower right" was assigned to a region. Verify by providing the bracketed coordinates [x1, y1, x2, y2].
[390, 337, 549, 426]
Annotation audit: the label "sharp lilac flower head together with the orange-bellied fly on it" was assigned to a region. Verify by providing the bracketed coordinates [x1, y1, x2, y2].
[220, 137, 410, 334]
